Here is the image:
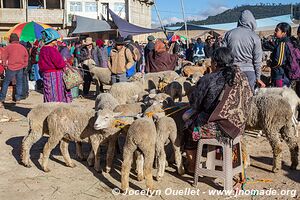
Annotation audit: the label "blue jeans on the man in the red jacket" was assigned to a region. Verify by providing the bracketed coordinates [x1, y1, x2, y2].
[0, 69, 23, 102]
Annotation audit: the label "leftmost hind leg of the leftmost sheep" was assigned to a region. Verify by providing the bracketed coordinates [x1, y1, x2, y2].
[21, 129, 43, 167]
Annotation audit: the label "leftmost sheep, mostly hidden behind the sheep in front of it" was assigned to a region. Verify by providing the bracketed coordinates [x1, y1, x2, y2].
[20, 102, 74, 167]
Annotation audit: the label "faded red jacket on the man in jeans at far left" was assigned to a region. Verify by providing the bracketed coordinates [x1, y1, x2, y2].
[2, 42, 28, 71]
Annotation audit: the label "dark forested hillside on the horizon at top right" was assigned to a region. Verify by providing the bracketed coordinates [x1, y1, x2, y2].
[173, 3, 291, 26]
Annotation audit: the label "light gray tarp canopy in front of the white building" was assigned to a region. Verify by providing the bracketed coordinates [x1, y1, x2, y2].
[72, 15, 113, 34]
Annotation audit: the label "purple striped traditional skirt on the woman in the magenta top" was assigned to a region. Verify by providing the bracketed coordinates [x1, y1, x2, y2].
[43, 71, 72, 103]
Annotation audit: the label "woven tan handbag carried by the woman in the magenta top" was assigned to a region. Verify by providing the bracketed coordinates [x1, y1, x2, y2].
[63, 64, 84, 90]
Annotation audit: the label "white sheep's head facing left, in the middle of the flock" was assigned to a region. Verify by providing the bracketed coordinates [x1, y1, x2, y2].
[94, 109, 121, 130]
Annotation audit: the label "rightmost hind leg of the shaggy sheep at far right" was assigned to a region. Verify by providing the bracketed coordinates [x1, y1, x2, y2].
[281, 124, 299, 170]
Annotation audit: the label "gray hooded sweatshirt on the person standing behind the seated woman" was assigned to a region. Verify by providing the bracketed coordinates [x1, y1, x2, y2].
[223, 10, 262, 80]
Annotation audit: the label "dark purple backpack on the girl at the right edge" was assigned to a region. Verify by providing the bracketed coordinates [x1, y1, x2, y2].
[286, 42, 300, 80]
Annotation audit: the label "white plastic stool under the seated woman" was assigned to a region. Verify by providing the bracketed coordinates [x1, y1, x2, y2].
[194, 136, 243, 190]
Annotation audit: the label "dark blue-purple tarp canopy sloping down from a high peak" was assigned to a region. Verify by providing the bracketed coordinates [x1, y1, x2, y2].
[108, 9, 162, 37]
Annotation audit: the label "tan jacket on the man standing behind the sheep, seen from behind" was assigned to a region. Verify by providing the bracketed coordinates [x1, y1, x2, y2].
[108, 47, 134, 74]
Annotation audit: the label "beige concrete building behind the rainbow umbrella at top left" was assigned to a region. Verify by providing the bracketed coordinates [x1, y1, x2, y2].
[0, 0, 65, 35]
